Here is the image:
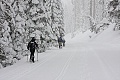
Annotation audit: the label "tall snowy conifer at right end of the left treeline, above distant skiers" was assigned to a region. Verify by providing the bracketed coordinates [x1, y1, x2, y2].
[51, 0, 64, 37]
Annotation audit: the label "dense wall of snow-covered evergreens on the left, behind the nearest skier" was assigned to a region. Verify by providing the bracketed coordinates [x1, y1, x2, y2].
[0, 0, 64, 67]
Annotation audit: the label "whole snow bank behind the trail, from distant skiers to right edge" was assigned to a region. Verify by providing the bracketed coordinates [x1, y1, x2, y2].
[65, 23, 120, 44]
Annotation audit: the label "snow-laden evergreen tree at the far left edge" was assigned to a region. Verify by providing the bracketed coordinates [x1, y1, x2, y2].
[0, 0, 16, 66]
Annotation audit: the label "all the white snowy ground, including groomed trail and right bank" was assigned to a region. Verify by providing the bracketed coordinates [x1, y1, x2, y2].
[0, 25, 120, 80]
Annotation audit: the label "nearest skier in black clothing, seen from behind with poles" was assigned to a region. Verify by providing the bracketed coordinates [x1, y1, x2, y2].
[27, 37, 38, 63]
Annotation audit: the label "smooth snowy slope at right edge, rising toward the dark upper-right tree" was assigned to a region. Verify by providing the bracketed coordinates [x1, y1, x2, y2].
[91, 24, 120, 43]
